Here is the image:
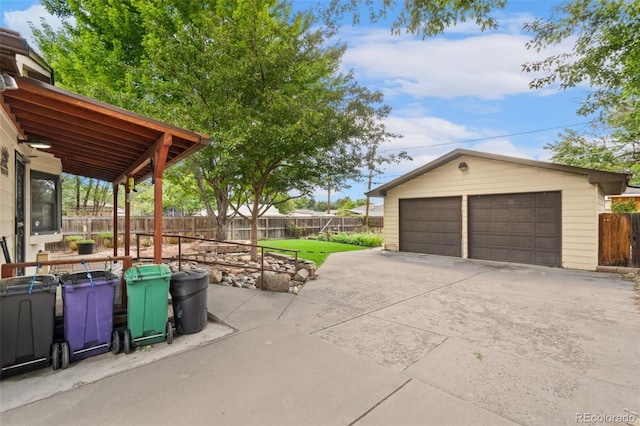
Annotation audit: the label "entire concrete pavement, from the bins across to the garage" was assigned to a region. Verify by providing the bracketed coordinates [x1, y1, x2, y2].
[0, 250, 640, 425]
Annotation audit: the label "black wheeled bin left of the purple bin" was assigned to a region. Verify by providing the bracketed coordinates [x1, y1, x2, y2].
[0, 275, 58, 378]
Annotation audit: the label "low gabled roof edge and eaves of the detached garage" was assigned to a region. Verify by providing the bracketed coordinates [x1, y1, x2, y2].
[366, 149, 631, 197]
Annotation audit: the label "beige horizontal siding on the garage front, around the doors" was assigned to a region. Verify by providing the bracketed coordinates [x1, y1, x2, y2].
[384, 156, 604, 270]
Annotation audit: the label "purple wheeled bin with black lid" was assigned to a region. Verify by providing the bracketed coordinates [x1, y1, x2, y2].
[54, 270, 120, 368]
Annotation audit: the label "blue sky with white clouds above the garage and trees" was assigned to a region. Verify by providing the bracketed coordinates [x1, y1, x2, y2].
[0, 0, 588, 202]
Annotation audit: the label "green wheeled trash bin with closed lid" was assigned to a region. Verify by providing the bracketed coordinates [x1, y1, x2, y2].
[122, 265, 173, 353]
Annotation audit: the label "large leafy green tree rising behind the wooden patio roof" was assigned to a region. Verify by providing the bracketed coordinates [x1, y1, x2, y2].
[35, 0, 400, 256]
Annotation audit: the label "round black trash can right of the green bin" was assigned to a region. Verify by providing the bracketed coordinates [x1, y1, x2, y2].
[169, 269, 209, 334]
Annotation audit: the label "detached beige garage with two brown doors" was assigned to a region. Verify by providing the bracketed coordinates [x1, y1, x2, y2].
[368, 149, 629, 270]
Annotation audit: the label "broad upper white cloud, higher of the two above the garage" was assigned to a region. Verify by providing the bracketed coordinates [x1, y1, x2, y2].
[344, 29, 567, 100]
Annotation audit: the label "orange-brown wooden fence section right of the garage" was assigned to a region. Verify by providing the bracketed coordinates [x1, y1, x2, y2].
[598, 213, 640, 268]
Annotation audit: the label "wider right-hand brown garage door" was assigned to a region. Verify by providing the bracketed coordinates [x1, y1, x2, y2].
[468, 192, 561, 266]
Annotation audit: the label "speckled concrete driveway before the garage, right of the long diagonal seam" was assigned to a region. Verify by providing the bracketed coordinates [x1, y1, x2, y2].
[280, 251, 640, 425]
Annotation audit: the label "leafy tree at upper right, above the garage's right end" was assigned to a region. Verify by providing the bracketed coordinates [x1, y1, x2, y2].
[523, 0, 640, 182]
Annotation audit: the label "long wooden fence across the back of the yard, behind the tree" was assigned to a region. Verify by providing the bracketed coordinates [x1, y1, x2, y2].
[46, 216, 382, 250]
